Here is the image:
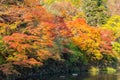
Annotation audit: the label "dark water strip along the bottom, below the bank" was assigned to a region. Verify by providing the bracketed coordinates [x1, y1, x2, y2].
[17, 72, 120, 80]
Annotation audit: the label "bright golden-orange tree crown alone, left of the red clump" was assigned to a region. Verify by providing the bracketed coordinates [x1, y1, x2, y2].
[67, 19, 102, 59]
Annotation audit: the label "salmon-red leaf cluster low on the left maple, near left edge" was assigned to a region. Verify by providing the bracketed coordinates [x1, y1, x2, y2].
[3, 33, 38, 52]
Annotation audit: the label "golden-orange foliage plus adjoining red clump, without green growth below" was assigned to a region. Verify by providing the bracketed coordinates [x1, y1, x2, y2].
[67, 18, 114, 60]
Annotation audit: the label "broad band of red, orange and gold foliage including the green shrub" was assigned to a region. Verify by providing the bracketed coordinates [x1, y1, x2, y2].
[0, 0, 119, 77]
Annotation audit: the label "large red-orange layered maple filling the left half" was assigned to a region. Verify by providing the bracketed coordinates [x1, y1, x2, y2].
[0, 0, 70, 69]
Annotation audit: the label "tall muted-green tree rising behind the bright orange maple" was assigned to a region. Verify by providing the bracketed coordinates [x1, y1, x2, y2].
[83, 0, 109, 26]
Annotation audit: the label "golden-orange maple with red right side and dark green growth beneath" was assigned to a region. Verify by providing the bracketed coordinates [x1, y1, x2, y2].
[66, 18, 116, 66]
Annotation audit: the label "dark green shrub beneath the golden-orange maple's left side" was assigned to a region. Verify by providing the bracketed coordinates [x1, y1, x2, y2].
[63, 42, 88, 65]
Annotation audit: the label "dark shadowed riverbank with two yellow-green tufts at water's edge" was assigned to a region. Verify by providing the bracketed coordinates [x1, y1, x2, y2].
[0, 59, 118, 80]
